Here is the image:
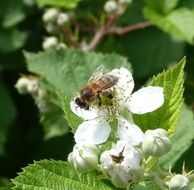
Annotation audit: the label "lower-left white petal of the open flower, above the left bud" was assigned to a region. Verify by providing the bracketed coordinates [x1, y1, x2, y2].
[74, 119, 111, 145]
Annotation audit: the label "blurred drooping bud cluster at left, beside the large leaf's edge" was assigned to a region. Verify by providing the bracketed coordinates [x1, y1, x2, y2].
[15, 76, 51, 113]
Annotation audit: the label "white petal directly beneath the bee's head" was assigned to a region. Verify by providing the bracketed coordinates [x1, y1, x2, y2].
[70, 101, 98, 120]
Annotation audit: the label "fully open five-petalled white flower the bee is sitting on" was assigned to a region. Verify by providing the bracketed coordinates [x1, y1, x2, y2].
[70, 67, 164, 146]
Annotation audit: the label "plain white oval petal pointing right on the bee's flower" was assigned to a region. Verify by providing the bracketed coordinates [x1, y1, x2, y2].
[127, 86, 164, 114]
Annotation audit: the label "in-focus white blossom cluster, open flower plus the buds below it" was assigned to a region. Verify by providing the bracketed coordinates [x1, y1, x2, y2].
[68, 68, 171, 188]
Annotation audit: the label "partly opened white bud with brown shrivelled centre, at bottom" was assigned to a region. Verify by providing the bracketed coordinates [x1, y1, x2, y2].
[100, 141, 143, 188]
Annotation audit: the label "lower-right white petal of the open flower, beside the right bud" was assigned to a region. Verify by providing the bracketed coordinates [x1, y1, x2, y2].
[117, 117, 144, 146]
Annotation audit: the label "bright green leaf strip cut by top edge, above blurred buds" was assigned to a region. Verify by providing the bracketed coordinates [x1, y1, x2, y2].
[37, 0, 81, 9]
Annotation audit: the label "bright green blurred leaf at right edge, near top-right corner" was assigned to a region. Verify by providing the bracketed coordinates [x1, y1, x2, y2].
[144, 8, 194, 44]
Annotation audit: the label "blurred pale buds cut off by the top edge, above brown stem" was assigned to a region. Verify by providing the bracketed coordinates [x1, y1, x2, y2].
[104, 0, 132, 15]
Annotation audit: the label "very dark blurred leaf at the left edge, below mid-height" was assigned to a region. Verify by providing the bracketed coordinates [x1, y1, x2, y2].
[0, 81, 16, 155]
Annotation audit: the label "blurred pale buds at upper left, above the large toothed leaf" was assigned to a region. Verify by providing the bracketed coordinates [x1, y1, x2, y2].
[42, 8, 70, 50]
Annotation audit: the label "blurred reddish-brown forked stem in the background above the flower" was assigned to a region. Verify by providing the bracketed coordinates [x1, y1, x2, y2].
[82, 19, 153, 52]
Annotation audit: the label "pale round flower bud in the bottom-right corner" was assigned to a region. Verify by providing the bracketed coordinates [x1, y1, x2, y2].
[168, 174, 189, 190]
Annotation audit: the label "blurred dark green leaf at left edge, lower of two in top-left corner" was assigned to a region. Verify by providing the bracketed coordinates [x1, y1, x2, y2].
[0, 28, 27, 53]
